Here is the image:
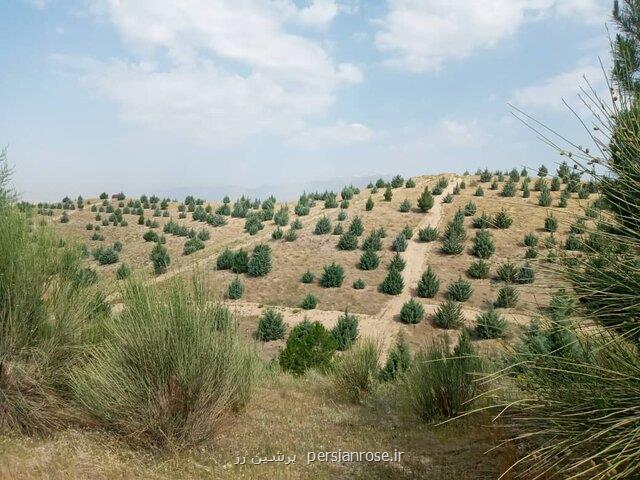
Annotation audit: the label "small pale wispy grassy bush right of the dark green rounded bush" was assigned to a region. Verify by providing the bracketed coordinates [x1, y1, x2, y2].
[332, 338, 380, 402]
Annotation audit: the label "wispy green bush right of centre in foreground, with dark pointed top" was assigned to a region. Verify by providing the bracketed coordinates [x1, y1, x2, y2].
[404, 330, 482, 420]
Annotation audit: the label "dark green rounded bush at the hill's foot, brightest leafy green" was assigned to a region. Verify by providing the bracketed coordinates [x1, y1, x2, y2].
[279, 319, 338, 375]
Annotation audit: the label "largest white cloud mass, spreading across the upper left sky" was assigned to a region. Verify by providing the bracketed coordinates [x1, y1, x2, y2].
[66, 0, 362, 145]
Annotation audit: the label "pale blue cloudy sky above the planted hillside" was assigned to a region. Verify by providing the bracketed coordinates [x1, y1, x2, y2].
[0, 0, 611, 201]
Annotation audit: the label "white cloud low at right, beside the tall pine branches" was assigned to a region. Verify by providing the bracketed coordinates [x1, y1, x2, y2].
[511, 64, 606, 110]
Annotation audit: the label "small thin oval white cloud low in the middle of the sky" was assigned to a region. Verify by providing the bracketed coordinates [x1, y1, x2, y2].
[289, 121, 373, 149]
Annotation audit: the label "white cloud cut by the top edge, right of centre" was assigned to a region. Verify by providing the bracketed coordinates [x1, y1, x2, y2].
[375, 0, 607, 72]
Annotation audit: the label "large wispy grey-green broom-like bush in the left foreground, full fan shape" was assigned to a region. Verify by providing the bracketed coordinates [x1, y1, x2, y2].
[71, 285, 259, 447]
